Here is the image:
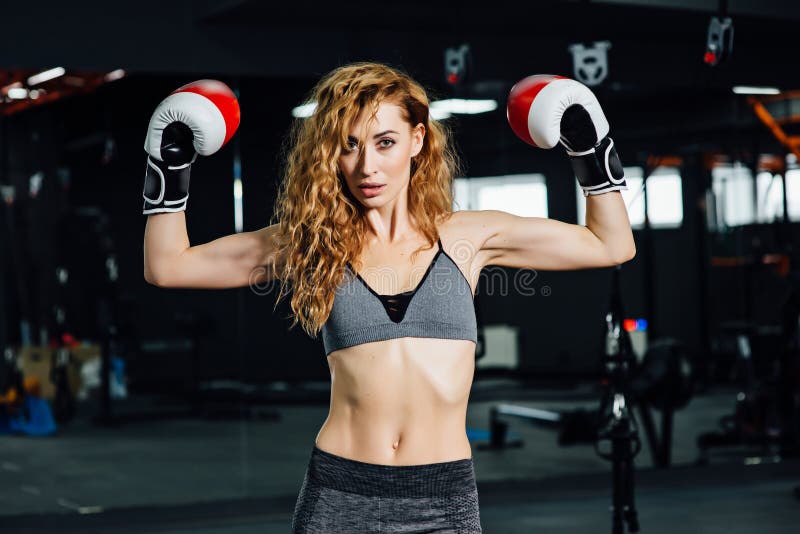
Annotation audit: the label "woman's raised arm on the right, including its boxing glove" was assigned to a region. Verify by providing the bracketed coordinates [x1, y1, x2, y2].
[476, 75, 636, 270]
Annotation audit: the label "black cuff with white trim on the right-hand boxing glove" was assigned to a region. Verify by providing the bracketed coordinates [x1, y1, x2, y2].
[567, 137, 628, 196]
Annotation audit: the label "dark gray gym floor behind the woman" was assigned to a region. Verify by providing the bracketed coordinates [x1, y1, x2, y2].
[0, 380, 800, 534]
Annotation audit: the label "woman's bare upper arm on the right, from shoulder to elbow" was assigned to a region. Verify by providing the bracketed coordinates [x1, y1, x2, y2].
[482, 210, 614, 271]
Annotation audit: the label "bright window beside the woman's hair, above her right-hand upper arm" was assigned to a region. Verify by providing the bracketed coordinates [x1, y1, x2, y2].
[453, 174, 547, 217]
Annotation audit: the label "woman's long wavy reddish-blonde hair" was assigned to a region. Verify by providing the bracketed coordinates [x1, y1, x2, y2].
[272, 63, 458, 337]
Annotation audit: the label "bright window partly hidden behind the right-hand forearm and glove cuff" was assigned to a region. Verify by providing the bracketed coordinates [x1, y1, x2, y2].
[575, 167, 683, 229]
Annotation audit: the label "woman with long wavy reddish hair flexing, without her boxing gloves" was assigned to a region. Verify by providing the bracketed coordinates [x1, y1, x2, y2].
[145, 63, 634, 533]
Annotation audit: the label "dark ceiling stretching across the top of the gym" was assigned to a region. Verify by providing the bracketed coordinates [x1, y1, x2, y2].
[0, 0, 800, 149]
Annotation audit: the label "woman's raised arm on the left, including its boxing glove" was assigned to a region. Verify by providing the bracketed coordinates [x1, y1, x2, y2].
[142, 80, 277, 294]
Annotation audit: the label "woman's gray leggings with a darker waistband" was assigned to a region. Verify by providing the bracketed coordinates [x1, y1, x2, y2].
[292, 446, 481, 534]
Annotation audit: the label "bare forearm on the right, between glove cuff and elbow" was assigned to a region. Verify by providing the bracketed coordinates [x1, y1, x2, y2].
[585, 195, 636, 263]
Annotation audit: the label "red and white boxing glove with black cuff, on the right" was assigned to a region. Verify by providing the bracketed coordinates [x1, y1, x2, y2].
[506, 74, 628, 196]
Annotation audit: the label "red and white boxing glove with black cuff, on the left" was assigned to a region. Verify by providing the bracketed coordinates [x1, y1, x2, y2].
[142, 80, 239, 215]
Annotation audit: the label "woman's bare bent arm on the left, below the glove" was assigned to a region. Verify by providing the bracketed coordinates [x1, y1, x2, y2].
[144, 212, 277, 288]
